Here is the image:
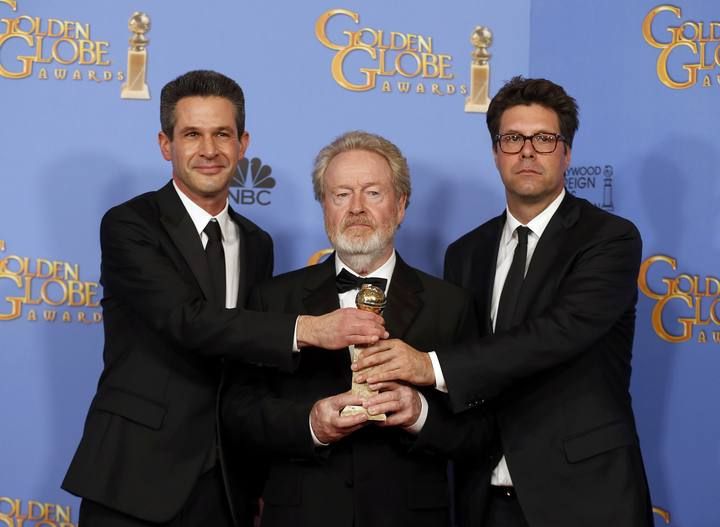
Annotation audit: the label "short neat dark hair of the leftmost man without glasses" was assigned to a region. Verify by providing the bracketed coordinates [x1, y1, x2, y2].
[160, 70, 245, 139]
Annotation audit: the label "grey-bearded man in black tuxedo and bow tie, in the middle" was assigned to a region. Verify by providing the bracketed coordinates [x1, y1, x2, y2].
[223, 132, 487, 527]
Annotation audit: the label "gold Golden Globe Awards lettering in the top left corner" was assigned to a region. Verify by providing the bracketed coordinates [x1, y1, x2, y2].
[0, 0, 125, 83]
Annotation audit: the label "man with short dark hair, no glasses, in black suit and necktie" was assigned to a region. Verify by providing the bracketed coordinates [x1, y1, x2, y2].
[63, 71, 385, 527]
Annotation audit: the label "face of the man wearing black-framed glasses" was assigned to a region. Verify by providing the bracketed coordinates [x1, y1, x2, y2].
[494, 104, 570, 222]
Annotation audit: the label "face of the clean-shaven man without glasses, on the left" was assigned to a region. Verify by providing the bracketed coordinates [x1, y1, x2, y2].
[158, 96, 250, 215]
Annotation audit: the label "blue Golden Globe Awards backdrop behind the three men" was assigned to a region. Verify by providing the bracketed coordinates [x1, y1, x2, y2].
[0, 0, 720, 527]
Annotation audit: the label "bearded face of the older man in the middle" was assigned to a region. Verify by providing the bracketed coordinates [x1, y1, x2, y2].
[322, 150, 407, 275]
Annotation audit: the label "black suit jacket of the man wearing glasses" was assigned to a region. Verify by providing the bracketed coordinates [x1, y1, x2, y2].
[439, 193, 652, 527]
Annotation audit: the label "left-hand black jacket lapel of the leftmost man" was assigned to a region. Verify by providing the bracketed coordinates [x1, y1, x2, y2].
[156, 181, 212, 304]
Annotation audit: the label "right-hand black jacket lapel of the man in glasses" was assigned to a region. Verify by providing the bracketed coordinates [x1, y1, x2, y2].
[514, 191, 580, 323]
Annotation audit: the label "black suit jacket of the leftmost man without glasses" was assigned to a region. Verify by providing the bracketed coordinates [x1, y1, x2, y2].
[62, 183, 295, 522]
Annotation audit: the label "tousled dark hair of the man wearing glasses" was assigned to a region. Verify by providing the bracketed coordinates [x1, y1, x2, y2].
[486, 76, 580, 148]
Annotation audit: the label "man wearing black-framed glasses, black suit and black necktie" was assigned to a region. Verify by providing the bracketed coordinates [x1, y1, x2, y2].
[357, 77, 652, 527]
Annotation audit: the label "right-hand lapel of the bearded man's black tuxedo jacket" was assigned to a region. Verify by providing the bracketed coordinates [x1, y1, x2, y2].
[383, 252, 423, 339]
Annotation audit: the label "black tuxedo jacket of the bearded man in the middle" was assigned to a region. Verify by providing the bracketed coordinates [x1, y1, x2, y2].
[223, 256, 487, 527]
